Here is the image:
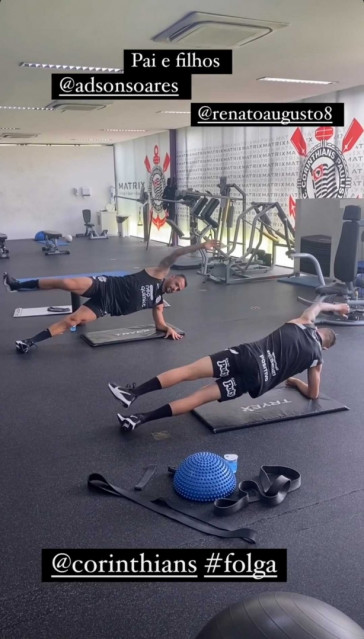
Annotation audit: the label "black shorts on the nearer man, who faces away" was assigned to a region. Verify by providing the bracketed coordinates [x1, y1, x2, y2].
[210, 344, 259, 402]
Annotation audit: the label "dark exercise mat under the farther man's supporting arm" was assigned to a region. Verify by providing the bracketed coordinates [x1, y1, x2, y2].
[81, 324, 184, 346]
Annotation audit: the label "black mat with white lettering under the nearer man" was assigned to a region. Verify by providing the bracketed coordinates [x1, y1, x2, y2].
[193, 387, 349, 433]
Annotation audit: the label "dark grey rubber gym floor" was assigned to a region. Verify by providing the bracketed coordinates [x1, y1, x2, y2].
[0, 238, 364, 639]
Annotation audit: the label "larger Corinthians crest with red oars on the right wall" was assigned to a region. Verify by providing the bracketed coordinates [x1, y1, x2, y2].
[291, 118, 363, 198]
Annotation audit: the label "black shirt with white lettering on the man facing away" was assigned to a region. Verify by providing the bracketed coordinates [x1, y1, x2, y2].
[245, 322, 322, 397]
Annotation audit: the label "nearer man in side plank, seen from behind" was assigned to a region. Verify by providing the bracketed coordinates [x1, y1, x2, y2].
[109, 302, 350, 431]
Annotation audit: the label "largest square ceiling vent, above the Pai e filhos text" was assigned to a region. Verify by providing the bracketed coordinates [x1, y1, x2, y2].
[153, 11, 288, 49]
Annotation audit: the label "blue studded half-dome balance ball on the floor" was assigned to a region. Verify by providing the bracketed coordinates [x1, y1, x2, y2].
[173, 452, 236, 501]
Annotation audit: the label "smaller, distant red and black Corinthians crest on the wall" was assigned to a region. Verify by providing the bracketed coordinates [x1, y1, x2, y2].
[144, 144, 170, 229]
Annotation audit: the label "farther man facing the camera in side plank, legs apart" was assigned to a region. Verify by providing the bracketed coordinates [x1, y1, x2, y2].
[4, 240, 219, 353]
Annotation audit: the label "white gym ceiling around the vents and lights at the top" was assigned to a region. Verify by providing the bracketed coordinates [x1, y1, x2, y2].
[0, 0, 364, 144]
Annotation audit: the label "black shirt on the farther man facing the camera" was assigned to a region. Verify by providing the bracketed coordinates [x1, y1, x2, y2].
[106, 270, 163, 315]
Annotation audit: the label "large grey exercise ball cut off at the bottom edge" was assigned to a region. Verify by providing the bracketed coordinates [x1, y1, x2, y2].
[196, 592, 364, 639]
